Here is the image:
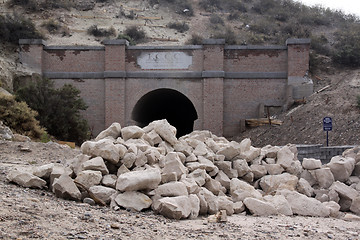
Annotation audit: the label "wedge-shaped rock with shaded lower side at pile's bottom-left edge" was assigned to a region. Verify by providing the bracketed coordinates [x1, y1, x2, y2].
[52, 174, 81, 201]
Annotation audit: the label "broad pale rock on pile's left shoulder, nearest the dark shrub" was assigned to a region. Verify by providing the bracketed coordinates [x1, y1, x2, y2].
[81, 139, 120, 164]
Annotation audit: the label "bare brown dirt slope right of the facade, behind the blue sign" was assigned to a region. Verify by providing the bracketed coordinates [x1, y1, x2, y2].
[237, 70, 360, 146]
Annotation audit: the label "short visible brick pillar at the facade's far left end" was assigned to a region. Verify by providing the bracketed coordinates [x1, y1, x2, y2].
[19, 39, 46, 74]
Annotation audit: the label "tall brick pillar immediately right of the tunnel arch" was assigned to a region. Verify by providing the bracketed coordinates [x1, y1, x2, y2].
[202, 39, 225, 136]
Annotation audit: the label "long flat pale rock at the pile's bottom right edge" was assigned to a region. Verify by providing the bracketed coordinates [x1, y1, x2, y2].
[276, 189, 330, 217]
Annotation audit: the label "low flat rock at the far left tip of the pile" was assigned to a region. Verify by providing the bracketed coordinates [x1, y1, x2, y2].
[6, 170, 46, 188]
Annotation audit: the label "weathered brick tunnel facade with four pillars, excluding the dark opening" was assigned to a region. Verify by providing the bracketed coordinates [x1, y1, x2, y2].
[20, 39, 311, 136]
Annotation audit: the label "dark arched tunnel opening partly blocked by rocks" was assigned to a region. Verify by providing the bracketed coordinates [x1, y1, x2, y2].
[131, 88, 198, 137]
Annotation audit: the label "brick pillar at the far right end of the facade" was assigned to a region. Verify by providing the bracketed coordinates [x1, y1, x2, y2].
[286, 39, 313, 100]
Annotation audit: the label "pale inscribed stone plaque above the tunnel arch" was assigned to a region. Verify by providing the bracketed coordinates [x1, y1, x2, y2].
[137, 52, 192, 70]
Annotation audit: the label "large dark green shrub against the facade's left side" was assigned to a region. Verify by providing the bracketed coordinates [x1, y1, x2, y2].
[16, 78, 89, 145]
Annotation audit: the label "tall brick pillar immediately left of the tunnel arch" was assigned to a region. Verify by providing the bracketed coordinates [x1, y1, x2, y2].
[103, 39, 127, 128]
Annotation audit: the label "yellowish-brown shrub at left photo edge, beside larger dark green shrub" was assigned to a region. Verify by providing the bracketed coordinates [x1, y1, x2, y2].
[0, 93, 46, 139]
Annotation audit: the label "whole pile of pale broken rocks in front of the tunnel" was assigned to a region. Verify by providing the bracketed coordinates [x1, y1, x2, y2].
[8, 120, 360, 219]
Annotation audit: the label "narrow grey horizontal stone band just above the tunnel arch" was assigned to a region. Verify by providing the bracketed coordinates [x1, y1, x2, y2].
[43, 71, 288, 79]
